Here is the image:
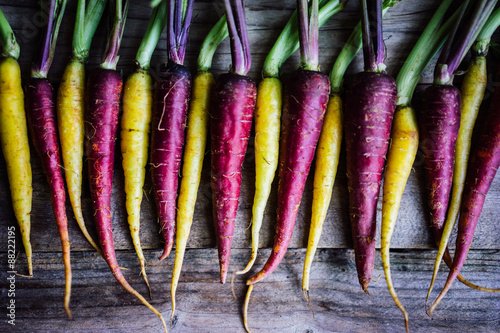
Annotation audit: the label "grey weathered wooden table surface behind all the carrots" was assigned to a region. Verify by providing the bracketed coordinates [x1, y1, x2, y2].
[0, 0, 500, 332]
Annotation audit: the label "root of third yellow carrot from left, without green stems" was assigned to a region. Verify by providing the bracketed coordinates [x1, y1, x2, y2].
[120, 69, 153, 297]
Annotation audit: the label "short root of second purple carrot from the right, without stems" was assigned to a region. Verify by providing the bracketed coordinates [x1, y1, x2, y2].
[420, 85, 460, 246]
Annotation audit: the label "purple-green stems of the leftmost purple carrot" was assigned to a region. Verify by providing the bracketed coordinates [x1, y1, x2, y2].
[31, 0, 67, 78]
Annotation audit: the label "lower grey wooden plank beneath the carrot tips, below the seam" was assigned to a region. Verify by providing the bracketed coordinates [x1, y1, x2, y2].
[1, 249, 500, 333]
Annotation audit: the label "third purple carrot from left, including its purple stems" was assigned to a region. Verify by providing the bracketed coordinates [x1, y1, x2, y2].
[151, 0, 193, 260]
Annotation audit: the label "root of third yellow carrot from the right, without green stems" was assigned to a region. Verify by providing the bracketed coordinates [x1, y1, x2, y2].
[302, 93, 343, 292]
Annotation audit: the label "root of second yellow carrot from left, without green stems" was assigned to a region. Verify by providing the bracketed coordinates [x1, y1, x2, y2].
[57, 59, 102, 256]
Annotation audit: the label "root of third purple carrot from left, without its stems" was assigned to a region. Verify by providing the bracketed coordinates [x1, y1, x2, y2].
[150, 62, 191, 260]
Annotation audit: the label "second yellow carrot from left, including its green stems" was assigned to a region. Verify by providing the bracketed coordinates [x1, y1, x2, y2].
[57, 0, 106, 256]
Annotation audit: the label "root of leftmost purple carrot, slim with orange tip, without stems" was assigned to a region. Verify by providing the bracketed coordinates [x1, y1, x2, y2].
[26, 78, 71, 317]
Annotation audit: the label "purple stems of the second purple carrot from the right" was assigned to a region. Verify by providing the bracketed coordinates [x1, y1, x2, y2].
[434, 0, 497, 85]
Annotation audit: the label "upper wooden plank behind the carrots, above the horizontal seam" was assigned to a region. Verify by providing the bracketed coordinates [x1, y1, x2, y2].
[0, 0, 500, 251]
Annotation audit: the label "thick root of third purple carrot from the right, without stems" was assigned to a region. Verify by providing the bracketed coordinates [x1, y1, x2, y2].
[345, 72, 397, 292]
